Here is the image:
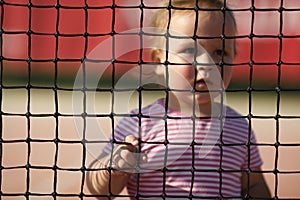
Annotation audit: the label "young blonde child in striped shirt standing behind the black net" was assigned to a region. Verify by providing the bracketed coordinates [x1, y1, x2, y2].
[87, 0, 270, 199]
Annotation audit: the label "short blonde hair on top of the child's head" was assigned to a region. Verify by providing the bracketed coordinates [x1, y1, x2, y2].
[150, 0, 237, 53]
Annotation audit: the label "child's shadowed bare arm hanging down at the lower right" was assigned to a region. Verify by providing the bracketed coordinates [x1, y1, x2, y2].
[242, 169, 271, 199]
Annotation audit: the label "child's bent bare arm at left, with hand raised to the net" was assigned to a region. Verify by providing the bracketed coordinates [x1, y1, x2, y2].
[87, 135, 138, 199]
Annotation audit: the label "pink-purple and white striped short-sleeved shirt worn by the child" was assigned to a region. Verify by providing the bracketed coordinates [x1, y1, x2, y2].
[104, 99, 262, 199]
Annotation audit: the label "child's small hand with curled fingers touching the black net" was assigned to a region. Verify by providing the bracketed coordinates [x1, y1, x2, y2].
[109, 135, 147, 174]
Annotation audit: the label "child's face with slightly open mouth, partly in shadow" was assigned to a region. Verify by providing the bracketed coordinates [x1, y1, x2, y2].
[152, 13, 235, 110]
